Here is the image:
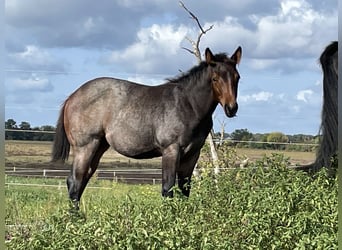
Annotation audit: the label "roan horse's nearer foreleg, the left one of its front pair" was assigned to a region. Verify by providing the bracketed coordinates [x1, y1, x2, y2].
[162, 144, 179, 197]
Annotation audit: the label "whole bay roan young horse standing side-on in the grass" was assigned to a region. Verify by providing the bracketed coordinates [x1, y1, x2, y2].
[52, 47, 242, 208]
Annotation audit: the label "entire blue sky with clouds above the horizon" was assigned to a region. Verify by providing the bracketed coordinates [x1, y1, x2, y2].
[5, 0, 338, 135]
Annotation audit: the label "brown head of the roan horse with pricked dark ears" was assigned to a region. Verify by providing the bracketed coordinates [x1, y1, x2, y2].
[205, 46, 242, 117]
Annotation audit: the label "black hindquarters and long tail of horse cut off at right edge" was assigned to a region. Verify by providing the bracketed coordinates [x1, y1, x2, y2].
[298, 41, 338, 176]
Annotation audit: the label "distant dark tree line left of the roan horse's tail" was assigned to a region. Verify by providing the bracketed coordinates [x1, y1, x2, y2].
[5, 119, 55, 141]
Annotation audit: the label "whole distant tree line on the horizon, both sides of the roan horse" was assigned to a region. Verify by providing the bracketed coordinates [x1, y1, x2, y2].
[5, 119, 319, 152]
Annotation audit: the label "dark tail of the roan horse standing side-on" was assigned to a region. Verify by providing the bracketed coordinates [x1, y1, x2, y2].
[52, 103, 70, 162]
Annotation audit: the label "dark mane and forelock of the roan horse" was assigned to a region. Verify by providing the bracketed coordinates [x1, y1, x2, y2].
[166, 53, 234, 83]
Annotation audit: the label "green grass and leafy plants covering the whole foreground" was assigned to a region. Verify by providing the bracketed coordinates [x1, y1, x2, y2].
[6, 151, 337, 249]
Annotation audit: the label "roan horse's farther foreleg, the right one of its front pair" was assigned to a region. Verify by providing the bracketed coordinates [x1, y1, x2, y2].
[177, 150, 200, 197]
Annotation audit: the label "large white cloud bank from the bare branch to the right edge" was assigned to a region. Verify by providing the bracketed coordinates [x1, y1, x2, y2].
[203, 0, 338, 63]
